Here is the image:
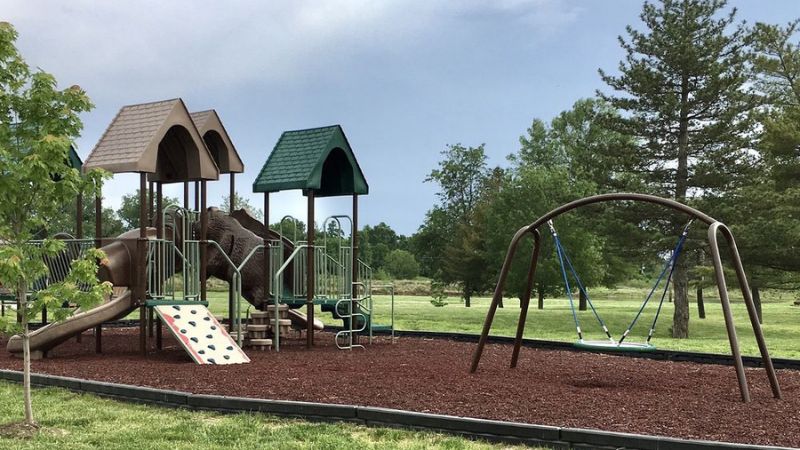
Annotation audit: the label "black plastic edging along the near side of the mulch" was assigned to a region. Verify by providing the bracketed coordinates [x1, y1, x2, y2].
[0, 370, 789, 450]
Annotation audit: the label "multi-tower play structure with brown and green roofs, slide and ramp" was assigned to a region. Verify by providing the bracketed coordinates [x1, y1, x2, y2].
[8, 99, 392, 364]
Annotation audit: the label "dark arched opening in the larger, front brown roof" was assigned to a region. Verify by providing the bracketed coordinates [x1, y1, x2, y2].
[151, 125, 200, 183]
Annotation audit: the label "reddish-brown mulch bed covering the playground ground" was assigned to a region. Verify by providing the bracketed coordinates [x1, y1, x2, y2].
[0, 329, 800, 447]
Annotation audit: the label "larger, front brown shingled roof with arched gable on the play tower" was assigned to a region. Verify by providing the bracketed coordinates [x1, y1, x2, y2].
[83, 98, 219, 182]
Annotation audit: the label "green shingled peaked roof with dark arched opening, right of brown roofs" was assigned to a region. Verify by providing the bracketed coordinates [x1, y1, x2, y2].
[253, 125, 369, 197]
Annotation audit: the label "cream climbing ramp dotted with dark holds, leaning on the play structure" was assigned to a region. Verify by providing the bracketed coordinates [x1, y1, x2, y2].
[154, 305, 250, 364]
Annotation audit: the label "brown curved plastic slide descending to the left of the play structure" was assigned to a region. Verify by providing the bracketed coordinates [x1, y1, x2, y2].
[6, 230, 146, 358]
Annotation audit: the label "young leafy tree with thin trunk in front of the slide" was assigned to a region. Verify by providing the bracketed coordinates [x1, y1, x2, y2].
[0, 22, 111, 426]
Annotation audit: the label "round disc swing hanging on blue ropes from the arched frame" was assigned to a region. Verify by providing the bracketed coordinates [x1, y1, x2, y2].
[547, 220, 692, 352]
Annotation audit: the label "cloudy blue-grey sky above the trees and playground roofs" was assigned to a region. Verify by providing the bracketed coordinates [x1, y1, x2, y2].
[0, 0, 800, 235]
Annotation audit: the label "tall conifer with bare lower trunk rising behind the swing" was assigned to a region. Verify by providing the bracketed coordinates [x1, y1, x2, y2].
[598, 0, 757, 338]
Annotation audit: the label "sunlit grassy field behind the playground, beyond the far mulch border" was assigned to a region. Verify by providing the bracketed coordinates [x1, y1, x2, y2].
[203, 288, 800, 358]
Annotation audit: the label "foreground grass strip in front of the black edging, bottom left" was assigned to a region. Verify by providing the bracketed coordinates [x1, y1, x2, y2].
[0, 382, 540, 450]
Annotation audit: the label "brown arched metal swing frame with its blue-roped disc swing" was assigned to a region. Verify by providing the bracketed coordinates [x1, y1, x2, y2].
[470, 193, 781, 403]
